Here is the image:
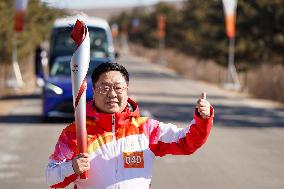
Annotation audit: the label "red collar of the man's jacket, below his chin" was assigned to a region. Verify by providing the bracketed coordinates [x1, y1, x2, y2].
[86, 98, 139, 131]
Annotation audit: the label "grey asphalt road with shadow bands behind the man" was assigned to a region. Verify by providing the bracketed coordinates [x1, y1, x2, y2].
[0, 54, 284, 189]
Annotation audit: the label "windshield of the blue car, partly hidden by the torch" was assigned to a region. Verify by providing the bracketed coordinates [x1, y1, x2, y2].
[50, 60, 97, 77]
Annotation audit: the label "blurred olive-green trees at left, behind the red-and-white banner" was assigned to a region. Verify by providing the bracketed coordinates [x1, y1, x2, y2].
[0, 0, 66, 63]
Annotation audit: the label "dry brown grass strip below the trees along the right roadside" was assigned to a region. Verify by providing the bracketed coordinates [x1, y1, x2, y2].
[130, 44, 284, 102]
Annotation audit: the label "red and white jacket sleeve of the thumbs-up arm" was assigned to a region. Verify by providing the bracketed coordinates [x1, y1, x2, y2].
[149, 107, 214, 156]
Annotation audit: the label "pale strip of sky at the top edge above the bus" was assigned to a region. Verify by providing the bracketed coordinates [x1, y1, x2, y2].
[41, 0, 181, 9]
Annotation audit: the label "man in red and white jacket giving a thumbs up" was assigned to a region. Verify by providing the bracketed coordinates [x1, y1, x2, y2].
[46, 63, 213, 189]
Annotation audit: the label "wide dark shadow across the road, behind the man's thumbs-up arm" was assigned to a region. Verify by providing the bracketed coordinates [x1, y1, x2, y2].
[138, 102, 284, 128]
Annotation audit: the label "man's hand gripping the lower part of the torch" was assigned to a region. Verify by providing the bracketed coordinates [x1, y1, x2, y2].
[72, 153, 90, 175]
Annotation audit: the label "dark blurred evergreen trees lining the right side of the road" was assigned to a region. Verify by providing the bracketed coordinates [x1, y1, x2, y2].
[112, 0, 284, 69]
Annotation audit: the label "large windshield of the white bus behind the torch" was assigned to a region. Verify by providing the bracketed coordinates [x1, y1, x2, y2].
[51, 27, 109, 58]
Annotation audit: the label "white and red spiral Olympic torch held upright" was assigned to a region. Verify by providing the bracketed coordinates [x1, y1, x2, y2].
[70, 20, 90, 179]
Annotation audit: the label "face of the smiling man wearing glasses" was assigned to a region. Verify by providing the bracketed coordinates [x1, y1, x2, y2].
[93, 71, 128, 114]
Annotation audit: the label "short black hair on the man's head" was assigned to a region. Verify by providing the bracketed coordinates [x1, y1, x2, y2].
[92, 62, 129, 86]
